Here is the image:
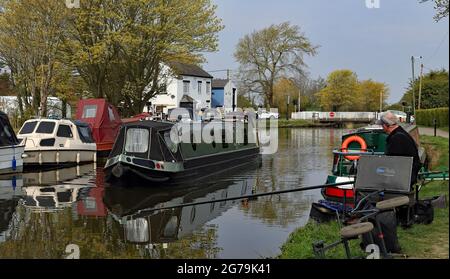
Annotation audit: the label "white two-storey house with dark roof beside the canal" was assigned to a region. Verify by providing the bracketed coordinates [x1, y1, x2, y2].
[145, 62, 213, 113]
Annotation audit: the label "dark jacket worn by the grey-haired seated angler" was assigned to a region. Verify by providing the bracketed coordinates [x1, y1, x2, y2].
[386, 127, 422, 185]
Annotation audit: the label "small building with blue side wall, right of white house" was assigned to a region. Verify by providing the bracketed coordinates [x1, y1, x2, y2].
[211, 79, 237, 111]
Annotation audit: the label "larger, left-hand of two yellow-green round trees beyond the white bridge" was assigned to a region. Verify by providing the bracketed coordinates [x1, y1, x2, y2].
[318, 70, 359, 111]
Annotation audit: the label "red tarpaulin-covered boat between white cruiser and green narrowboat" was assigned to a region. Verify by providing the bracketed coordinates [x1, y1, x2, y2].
[76, 99, 122, 151]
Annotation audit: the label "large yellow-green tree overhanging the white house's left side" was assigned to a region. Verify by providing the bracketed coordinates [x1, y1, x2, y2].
[66, 0, 223, 114]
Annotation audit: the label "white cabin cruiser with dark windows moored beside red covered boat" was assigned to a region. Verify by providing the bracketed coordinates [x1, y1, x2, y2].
[18, 119, 97, 166]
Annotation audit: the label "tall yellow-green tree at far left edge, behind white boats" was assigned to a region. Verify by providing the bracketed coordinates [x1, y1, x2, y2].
[0, 0, 67, 116]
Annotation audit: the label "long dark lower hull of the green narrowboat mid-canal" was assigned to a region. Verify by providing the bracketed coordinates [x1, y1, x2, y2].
[105, 148, 261, 186]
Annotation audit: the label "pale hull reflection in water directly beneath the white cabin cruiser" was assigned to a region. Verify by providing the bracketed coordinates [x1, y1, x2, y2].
[22, 164, 95, 186]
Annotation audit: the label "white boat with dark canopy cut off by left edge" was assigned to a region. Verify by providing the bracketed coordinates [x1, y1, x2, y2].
[0, 112, 24, 174]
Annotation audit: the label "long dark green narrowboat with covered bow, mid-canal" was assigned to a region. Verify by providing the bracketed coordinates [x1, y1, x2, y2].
[105, 120, 260, 184]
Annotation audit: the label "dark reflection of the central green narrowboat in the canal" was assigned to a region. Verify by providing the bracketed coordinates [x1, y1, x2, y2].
[104, 173, 255, 244]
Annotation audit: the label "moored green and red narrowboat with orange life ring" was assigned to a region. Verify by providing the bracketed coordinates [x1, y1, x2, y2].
[322, 123, 426, 205]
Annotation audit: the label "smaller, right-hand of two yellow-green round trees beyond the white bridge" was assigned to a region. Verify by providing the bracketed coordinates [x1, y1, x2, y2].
[358, 79, 389, 111]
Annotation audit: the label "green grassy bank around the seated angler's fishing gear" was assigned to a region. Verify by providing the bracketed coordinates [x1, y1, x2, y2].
[280, 136, 449, 259]
